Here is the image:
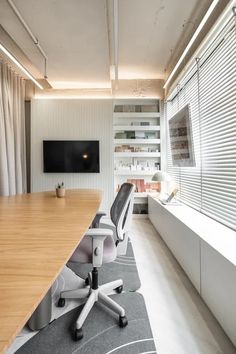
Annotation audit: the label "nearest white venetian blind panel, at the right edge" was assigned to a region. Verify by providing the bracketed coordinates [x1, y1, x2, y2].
[199, 15, 236, 228]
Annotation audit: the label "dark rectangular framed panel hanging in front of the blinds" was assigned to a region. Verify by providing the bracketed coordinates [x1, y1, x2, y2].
[169, 105, 195, 167]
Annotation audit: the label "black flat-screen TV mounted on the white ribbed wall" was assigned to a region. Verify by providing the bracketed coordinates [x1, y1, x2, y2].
[43, 140, 99, 173]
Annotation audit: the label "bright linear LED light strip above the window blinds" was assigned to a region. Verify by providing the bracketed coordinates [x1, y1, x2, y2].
[163, 0, 219, 88]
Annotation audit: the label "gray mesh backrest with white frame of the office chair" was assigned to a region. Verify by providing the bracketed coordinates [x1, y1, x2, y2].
[110, 183, 135, 241]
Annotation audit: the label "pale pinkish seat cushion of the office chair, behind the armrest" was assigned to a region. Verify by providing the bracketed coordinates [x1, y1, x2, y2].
[70, 235, 116, 264]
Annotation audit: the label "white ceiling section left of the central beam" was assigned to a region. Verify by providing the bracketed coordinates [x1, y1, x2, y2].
[1, 0, 110, 88]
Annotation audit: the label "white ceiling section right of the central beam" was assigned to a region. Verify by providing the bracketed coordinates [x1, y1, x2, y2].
[119, 0, 210, 79]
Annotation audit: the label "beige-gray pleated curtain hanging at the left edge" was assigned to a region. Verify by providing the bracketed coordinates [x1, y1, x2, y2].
[0, 61, 26, 195]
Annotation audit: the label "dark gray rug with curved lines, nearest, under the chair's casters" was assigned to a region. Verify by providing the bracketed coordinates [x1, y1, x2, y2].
[16, 293, 156, 354]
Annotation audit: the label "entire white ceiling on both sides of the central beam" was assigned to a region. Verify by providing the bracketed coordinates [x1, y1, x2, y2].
[0, 0, 211, 89]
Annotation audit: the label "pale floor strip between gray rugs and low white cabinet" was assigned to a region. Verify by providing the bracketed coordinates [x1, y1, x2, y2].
[130, 219, 236, 354]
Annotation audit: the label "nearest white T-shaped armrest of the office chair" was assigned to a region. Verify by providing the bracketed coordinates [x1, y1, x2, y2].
[85, 229, 113, 267]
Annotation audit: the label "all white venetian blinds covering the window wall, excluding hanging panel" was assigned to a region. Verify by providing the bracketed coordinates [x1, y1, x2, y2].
[166, 13, 236, 229]
